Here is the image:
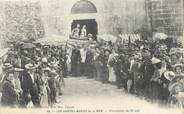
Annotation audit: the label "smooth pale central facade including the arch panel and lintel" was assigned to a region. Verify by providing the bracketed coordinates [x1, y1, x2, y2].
[42, 0, 146, 34]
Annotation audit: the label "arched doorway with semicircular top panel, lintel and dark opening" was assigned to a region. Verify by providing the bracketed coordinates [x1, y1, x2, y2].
[71, 0, 98, 39]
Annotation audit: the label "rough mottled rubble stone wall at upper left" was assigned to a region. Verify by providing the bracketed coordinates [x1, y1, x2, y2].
[0, 1, 44, 41]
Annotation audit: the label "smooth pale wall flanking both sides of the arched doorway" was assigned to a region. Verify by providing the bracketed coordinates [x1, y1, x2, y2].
[44, 0, 147, 35]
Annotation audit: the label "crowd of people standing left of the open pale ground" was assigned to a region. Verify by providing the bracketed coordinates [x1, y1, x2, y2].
[1, 42, 66, 107]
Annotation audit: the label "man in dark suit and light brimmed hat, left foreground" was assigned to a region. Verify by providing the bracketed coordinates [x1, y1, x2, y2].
[21, 64, 40, 107]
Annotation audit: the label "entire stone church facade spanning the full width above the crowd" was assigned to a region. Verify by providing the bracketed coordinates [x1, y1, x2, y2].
[0, 0, 184, 45]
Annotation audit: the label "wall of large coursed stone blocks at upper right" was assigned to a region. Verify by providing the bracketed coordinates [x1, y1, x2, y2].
[146, 0, 184, 41]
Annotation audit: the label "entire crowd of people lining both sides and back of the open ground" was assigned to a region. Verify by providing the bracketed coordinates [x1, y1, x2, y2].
[1, 33, 184, 107]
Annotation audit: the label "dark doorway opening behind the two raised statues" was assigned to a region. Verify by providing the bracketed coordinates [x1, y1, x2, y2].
[71, 19, 98, 40]
